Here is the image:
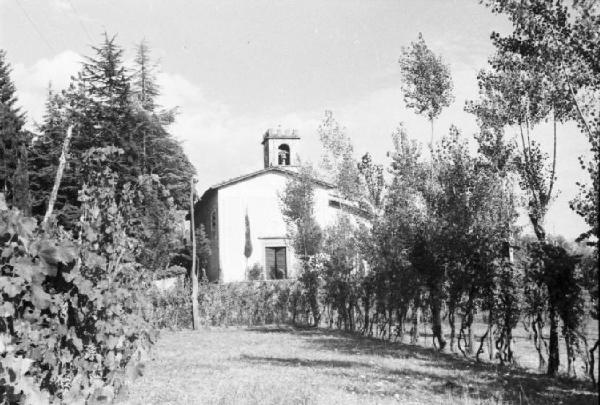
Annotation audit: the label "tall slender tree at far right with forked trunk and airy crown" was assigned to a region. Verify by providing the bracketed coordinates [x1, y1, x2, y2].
[467, 4, 600, 375]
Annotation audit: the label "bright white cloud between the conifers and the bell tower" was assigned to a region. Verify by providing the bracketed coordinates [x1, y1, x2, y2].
[158, 73, 320, 192]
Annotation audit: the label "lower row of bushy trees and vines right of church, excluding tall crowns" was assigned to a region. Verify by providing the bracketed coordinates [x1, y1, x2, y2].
[283, 113, 598, 376]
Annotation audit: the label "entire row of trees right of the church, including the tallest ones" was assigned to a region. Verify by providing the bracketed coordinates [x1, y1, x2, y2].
[283, 0, 600, 378]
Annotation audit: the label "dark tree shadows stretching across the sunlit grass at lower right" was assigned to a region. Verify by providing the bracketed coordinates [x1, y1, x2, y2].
[245, 326, 598, 404]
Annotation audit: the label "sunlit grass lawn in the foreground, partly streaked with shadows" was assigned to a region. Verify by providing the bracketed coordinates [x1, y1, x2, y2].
[120, 326, 598, 404]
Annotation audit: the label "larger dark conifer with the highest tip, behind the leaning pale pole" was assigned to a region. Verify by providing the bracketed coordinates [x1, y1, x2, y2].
[29, 34, 141, 228]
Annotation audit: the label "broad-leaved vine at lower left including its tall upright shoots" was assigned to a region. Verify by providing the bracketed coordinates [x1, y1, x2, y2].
[0, 150, 156, 404]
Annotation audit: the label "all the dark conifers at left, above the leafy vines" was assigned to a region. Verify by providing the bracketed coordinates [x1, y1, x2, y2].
[0, 34, 194, 223]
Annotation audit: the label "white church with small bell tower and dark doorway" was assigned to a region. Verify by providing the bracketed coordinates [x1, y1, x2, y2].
[195, 130, 358, 282]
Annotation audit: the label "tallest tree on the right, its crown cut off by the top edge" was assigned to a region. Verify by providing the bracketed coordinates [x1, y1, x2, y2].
[470, 0, 600, 375]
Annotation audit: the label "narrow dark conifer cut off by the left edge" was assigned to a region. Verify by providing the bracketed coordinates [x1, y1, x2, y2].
[0, 50, 30, 213]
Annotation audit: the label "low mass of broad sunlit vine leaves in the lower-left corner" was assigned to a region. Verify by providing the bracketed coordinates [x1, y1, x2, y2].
[0, 210, 154, 404]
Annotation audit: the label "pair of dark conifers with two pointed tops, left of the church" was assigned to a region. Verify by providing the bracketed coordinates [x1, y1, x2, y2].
[30, 34, 194, 227]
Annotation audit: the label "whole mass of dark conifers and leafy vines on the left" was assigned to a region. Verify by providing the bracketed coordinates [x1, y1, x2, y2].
[0, 35, 195, 404]
